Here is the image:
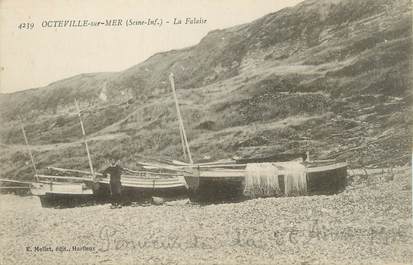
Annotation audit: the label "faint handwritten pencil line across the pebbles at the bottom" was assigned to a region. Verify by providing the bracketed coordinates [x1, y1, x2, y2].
[97, 220, 408, 252]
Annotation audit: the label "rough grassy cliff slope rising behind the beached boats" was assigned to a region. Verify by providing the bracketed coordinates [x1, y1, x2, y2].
[0, 0, 412, 177]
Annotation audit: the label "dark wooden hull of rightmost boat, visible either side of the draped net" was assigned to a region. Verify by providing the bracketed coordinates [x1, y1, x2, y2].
[185, 163, 347, 202]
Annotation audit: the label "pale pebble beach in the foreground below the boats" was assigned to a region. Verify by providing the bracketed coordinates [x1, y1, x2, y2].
[0, 168, 413, 265]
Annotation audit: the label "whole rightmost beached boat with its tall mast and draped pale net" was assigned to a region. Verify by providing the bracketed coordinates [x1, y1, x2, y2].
[166, 74, 347, 202]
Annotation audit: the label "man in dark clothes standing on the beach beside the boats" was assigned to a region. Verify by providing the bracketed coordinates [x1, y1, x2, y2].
[102, 157, 122, 208]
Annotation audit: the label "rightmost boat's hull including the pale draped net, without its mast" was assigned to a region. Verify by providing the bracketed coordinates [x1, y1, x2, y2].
[185, 161, 347, 202]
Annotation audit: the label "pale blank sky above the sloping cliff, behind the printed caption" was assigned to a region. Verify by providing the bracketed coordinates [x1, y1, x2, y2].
[0, 0, 302, 93]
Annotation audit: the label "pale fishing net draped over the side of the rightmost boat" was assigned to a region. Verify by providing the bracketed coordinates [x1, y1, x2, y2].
[244, 161, 307, 198]
